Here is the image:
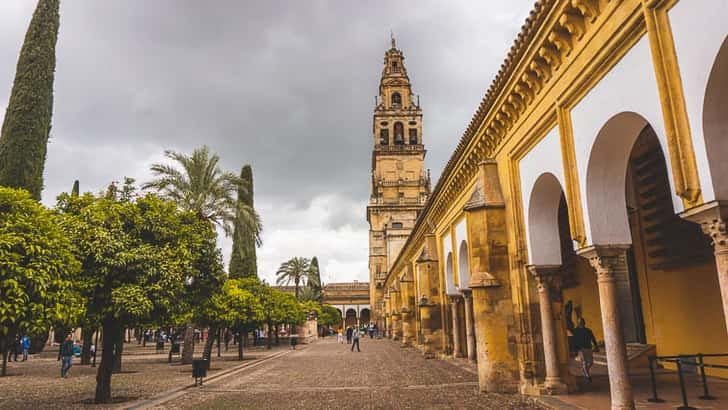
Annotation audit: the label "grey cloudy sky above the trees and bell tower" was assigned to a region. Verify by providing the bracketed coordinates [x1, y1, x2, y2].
[0, 0, 533, 282]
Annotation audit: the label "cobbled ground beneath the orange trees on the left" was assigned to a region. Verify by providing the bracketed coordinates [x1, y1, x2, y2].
[0, 341, 290, 410]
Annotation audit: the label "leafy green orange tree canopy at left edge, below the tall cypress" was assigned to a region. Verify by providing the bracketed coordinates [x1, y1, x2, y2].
[0, 186, 83, 375]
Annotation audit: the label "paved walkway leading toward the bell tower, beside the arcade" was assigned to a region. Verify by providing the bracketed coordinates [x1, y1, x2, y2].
[176, 338, 540, 409]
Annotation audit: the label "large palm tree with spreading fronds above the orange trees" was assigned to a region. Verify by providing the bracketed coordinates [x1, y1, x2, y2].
[142, 146, 262, 363]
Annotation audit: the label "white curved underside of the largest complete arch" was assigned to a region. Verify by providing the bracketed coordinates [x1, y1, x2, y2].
[585, 111, 672, 245]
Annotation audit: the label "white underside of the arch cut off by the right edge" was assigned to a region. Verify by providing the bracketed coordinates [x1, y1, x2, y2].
[703, 36, 728, 200]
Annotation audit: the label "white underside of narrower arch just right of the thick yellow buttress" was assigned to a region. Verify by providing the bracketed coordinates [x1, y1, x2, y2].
[527, 172, 568, 265]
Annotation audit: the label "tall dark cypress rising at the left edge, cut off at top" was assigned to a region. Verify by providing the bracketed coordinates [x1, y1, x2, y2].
[0, 0, 59, 200]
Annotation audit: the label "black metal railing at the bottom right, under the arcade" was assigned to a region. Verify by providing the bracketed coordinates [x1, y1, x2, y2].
[647, 353, 728, 410]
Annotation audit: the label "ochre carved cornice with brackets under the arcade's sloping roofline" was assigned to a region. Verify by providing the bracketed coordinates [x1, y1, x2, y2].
[382, 0, 603, 288]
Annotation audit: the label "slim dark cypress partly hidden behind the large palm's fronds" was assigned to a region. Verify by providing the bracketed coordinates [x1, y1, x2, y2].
[228, 165, 258, 278]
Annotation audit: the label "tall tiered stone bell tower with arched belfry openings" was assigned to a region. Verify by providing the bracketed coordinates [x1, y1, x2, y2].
[367, 37, 430, 329]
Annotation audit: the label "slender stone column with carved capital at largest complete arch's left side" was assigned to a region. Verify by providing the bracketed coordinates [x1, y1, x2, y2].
[577, 245, 635, 410]
